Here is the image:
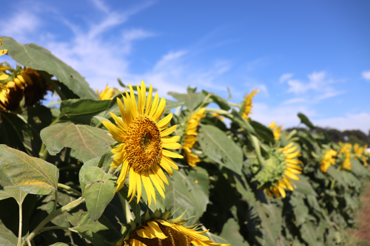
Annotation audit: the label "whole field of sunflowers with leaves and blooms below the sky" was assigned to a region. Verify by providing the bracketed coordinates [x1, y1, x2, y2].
[0, 37, 370, 246]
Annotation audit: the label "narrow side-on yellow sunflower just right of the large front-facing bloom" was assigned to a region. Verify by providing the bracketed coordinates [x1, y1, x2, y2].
[184, 108, 206, 167]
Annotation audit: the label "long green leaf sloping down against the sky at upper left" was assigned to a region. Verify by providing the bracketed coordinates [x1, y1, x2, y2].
[1, 37, 98, 99]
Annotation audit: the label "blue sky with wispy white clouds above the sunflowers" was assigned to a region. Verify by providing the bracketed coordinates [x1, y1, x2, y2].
[0, 0, 370, 133]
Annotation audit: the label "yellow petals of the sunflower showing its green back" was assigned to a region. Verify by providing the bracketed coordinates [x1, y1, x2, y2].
[265, 142, 302, 198]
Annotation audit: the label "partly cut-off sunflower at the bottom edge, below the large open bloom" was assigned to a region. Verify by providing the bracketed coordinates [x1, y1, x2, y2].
[117, 210, 230, 246]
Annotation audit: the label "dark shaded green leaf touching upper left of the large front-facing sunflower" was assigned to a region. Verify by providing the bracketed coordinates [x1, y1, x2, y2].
[60, 99, 110, 124]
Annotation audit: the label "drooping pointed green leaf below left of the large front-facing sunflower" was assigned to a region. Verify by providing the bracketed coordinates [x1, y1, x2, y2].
[83, 167, 115, 221]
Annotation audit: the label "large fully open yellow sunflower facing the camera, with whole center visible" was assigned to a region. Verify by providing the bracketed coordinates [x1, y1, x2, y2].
[103, 81, 183, 205]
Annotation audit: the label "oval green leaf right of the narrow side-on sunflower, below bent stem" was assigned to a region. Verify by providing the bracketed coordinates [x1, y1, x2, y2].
[198, 125, 243, 174]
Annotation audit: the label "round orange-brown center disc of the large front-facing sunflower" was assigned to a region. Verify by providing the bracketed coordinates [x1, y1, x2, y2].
[124, 115, 162, 172]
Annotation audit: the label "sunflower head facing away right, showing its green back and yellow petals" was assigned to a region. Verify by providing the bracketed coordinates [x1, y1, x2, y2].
[253, 143, 302, 198]
